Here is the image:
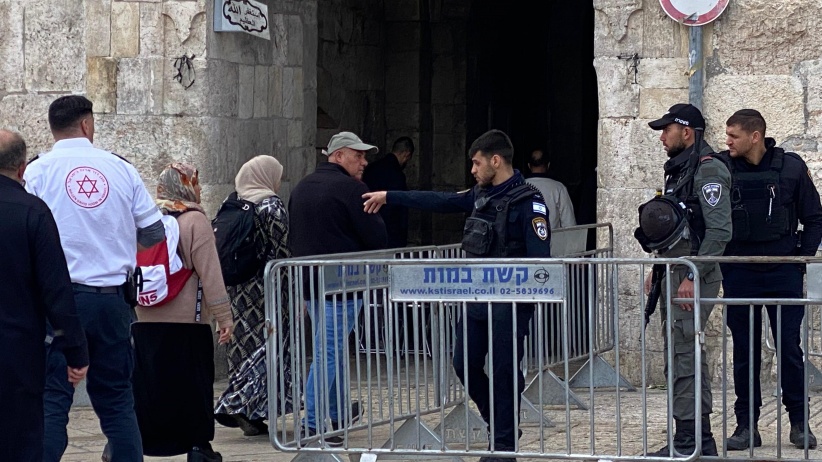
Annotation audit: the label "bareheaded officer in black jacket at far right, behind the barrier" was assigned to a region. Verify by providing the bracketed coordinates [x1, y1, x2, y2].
[720, 109, 822, 450]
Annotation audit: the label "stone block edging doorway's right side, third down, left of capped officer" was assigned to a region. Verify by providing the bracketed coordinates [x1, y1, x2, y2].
[597, 119, 666, 189]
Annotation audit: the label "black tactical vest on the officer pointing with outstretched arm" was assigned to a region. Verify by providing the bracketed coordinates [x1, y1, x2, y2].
[462, 183, 539, 258]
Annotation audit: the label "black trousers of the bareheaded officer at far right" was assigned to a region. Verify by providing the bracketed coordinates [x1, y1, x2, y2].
[722, 264, 807, 426]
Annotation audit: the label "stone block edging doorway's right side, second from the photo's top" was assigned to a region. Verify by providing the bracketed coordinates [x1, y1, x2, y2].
[594, 58, 639, 118]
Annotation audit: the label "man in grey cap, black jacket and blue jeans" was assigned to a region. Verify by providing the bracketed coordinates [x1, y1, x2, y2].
[288, 132, 388, 446]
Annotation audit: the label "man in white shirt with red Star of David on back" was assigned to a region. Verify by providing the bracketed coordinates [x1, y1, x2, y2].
[25, 95, 165, 461]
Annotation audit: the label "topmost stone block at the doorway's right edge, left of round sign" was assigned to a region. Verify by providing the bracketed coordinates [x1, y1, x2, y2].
[594, 0, 643, 56]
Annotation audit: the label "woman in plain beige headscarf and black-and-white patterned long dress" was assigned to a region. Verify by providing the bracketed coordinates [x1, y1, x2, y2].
[215, 155, 293, 436]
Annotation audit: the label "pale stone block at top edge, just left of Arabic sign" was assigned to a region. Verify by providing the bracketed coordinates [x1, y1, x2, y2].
[163, 1, 206, 58]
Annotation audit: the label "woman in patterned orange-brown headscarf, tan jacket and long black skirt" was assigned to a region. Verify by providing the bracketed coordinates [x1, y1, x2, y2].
[132, 163, 234, 462]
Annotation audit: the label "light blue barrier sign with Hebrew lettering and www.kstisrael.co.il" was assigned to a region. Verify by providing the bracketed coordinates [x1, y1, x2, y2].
[389, 264, 565, 302]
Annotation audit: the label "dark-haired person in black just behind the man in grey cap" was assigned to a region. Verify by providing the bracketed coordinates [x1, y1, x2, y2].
[362, 136, 414, 249]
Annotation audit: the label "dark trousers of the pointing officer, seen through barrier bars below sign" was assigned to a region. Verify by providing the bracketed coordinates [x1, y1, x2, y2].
[454, 303, 534, 451]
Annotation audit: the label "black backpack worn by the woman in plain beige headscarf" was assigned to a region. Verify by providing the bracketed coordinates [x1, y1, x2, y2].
[211, 191, 264, 286]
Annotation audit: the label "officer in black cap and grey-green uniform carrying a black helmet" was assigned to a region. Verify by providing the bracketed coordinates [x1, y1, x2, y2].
[636, 104, 731, 457]
